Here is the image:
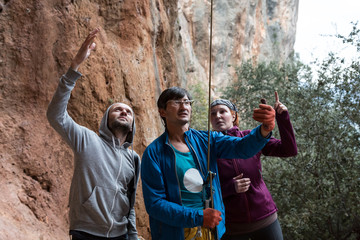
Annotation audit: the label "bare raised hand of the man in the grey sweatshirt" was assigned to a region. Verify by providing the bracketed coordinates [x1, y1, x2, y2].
[70, 28, 100, 71]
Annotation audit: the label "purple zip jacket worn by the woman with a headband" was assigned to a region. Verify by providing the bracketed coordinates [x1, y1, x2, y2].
[218, 111, 297, 223]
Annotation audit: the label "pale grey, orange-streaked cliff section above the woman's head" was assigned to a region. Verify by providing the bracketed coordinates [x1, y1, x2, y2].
[178, 0, 299, 95]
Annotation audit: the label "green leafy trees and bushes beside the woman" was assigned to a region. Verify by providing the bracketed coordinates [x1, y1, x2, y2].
[219, 24, 360, 239]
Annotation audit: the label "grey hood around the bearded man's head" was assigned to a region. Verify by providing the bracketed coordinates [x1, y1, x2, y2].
[99, 103, 135, 148]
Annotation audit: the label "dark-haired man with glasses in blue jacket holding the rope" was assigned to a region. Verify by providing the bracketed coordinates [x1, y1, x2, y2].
[141, 87, 275, 240]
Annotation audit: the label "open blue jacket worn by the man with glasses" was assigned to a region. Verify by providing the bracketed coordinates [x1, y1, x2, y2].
[141, 126, 269, 240]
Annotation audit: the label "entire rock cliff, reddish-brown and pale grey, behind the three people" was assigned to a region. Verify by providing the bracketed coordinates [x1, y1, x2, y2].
[0, 0, 298, 240]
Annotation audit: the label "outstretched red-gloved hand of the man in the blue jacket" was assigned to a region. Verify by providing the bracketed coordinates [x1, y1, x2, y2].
[253, 104, 275, 137]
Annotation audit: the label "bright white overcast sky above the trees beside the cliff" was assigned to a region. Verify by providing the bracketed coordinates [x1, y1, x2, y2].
[295, 0, 360, 63]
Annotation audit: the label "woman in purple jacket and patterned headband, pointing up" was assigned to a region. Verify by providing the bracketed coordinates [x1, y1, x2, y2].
[211, 92, 297, 240]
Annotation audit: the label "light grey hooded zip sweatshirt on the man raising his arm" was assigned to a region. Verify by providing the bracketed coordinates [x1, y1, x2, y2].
[47, 69, 140, 240]
